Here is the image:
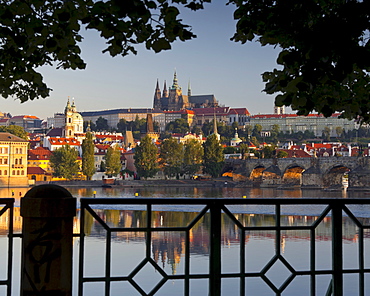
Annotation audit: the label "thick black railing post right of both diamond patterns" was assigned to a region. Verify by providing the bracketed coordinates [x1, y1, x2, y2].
[331, 202, 343, 296]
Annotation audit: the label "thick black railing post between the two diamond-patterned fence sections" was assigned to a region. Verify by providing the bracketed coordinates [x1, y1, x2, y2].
[209, 203, 221, 296]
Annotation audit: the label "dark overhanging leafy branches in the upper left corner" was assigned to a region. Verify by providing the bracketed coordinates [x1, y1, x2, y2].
[0, 0, 209, 102]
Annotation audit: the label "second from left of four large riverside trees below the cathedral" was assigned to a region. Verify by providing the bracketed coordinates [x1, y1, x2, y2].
[159, 137, 184, 178]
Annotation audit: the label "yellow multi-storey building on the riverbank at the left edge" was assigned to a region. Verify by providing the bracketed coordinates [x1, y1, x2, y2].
[0, 133, 28, 187]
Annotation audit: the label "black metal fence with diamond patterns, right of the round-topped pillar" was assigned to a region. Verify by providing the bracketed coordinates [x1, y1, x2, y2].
[78, 198, 370, 296]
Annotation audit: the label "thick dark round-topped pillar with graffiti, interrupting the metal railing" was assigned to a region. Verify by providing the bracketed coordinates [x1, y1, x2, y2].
[21, 185, 76, 296]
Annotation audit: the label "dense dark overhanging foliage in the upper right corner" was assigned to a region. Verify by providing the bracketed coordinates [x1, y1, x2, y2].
[230, 0, 370, 121]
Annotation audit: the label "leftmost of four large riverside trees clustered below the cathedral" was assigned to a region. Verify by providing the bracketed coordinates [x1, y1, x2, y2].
[134, 136, 159, 179]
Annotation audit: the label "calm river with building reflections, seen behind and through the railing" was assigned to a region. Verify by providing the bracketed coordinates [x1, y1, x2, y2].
[0, 186, 370, 296]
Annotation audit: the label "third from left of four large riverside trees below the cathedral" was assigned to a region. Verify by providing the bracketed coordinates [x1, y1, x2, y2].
[184, 139, 204, 176]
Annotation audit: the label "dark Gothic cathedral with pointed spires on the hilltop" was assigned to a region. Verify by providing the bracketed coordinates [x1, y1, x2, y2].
[153, 72, 218, 111]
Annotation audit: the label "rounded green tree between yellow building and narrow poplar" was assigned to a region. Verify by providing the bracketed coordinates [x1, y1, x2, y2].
[50, 145, 79, 180]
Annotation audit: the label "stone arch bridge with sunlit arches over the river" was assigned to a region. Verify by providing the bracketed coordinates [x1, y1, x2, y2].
[225, 157, 370, 190]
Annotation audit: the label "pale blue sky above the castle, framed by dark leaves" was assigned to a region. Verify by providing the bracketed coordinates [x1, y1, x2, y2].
[0, 0, 286, 119]
